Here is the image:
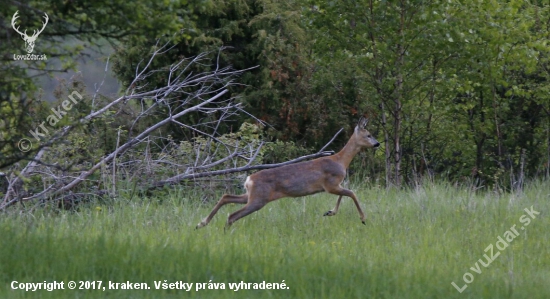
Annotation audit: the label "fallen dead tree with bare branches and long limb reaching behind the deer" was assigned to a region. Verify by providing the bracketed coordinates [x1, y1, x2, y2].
[0, 41, 342, 211]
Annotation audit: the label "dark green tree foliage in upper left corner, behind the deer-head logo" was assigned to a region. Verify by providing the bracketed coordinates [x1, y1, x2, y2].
[0, 0, 197, 168]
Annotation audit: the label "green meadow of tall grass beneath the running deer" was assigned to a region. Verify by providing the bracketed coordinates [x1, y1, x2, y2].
[0, 182, 550, 298]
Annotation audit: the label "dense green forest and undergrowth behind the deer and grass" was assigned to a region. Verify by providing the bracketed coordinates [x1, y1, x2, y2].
[0, 0, 550, 209]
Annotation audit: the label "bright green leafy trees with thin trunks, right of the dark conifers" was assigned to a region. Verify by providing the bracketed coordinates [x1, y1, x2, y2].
[309, 0, 550, 185]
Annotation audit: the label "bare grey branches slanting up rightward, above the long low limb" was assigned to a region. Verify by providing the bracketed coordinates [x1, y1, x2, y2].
[0, 43, 259, 210]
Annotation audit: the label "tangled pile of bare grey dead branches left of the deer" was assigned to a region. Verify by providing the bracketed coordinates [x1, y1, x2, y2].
[0, 44, 331, 210]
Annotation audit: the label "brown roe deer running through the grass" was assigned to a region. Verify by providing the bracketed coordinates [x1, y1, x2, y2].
[196, 117, 380, 228]
